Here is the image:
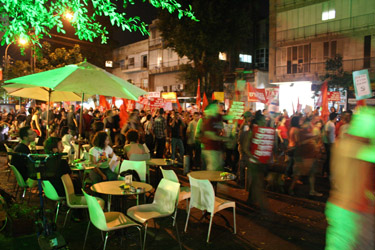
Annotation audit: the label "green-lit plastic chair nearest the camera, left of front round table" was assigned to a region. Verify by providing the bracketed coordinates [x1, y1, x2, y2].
[82, 189, 142, 249]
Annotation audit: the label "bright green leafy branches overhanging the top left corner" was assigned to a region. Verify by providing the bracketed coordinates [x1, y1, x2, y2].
[0, 0, 196, 45]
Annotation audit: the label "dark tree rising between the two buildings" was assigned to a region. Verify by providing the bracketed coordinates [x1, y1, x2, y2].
[158, 0, 254, 94]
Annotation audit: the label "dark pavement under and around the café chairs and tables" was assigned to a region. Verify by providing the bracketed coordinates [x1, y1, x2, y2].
[0, 162, 328, 250]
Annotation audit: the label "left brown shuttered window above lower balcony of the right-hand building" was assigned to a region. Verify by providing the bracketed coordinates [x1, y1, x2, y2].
[287, 44, 311, 74]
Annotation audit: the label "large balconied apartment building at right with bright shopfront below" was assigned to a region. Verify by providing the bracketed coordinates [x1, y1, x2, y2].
[269, 0, 375, 112]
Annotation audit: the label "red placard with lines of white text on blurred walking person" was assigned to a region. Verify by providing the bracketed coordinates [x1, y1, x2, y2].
[251, 126, 275, 164]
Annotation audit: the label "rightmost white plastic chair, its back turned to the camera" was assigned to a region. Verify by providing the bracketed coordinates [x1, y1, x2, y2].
[185, 175, 236, 242]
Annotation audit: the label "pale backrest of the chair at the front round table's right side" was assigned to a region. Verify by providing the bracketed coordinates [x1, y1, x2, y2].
[153, 178, 180, 214]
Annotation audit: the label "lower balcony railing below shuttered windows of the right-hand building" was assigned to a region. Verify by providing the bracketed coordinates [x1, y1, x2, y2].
[276, 57, 375, 77]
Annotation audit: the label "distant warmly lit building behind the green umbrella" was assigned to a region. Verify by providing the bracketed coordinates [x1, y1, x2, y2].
[113, 20, 190, 92]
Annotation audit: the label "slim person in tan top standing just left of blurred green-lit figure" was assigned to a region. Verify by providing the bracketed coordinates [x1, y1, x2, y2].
[186, 112, 200, 169]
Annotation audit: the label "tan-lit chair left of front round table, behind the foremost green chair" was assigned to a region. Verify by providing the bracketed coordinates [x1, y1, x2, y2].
[61, 174, 104, 227]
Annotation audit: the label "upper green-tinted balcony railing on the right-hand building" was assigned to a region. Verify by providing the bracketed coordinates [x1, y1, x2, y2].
[276, 13, 375, 42]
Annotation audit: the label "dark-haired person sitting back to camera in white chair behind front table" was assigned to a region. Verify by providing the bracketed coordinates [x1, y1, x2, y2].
[124, 129, 150, 160]
